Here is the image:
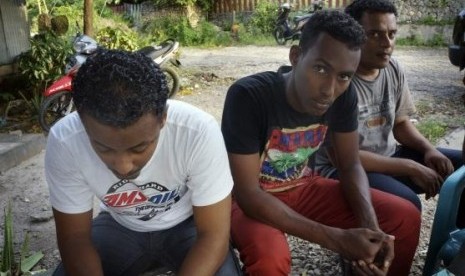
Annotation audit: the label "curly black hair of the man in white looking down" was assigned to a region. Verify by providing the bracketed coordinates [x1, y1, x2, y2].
[72, 49, 169, 128]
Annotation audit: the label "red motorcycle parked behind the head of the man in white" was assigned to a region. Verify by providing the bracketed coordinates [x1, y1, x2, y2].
[39, 33, 181, 132]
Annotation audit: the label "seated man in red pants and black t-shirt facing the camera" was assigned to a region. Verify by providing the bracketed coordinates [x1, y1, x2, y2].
[222, 8, 421, 276]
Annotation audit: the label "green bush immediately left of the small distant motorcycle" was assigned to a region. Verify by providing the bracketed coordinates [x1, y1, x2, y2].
[247, 1, 278, 34]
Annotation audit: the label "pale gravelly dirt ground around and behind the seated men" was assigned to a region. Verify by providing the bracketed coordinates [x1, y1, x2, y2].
[0, 46, 465, 275]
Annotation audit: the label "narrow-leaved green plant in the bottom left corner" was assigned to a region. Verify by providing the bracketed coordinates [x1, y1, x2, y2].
[0, 203, 45, 276]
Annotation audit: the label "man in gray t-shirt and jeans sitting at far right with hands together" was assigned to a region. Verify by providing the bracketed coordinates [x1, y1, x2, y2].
[316, 0, 462, 209]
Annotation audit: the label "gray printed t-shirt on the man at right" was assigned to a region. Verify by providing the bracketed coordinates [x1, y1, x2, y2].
[315, 58, 415, 176]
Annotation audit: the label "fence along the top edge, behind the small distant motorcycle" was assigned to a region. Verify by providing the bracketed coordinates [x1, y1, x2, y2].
[213, 0, 352, 14]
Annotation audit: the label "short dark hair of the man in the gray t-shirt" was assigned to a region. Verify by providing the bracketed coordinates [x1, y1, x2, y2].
[345, 0, 397, 22]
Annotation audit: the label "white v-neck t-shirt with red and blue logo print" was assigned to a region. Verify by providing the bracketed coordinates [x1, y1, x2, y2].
[45, 100, 233, 232]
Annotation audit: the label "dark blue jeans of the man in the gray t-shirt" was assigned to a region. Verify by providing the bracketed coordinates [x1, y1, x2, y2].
[330, 146, 463, 210]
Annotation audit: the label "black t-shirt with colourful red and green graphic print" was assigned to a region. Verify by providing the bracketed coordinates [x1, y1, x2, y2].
[221, 66, 357, 192]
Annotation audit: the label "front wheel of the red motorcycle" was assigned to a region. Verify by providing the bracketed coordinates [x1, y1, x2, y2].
[39, 91, 74, 132]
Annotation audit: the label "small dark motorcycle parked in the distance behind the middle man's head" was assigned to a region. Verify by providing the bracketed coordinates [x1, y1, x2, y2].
[273, 3, 323, 45]
